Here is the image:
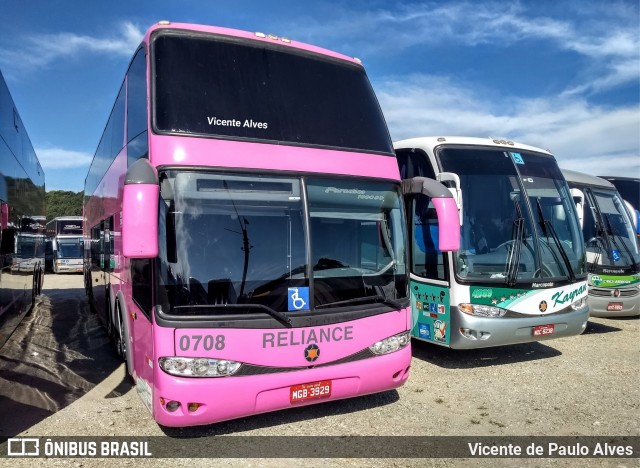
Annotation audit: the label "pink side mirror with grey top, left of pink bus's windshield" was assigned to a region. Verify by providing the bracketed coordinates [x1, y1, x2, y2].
[122, 159, 160, 258]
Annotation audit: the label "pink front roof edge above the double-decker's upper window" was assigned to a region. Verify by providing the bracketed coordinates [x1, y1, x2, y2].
[143, 21, 361, 65]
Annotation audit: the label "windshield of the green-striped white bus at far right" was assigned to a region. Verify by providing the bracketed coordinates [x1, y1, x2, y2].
[583, 189, 640, 269]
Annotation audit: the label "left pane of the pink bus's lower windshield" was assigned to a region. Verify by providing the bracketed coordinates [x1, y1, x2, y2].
[160, 173, 308, 311]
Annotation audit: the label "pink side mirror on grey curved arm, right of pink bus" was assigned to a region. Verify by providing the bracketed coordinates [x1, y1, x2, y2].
[402, 177, 460, 252]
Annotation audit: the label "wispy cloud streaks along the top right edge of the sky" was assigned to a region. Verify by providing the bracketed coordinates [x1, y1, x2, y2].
[289, 1, 640, 94]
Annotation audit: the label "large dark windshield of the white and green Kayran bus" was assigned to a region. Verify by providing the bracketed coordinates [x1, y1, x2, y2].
[438, 147, 585, 284]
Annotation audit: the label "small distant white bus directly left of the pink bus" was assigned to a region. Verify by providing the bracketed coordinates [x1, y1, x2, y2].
[47, 216, 84, 273]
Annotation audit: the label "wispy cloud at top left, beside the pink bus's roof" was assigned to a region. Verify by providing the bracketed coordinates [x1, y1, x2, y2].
[0, 22, 144, 70]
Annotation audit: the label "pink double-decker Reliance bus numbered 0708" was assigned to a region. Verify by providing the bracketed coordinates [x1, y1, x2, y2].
[84, 22, 459, 426]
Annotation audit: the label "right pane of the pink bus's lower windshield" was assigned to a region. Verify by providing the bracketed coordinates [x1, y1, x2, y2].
[307, 179, 407, 306]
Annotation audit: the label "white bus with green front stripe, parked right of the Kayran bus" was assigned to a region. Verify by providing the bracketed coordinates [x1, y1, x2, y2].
[562, 169, 640, 317]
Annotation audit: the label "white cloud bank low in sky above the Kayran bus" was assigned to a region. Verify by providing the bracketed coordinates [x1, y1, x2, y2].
[374, 75, 640, 177]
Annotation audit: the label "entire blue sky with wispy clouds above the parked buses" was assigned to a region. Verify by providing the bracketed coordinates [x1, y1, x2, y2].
[0, 0, 640, 191]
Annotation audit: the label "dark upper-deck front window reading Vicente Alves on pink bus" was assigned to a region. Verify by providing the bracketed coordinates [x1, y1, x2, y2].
[151, 32, 393, 155]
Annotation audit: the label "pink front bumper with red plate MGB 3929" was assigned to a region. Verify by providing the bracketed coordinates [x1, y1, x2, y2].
[152, 345, 411, 427]
